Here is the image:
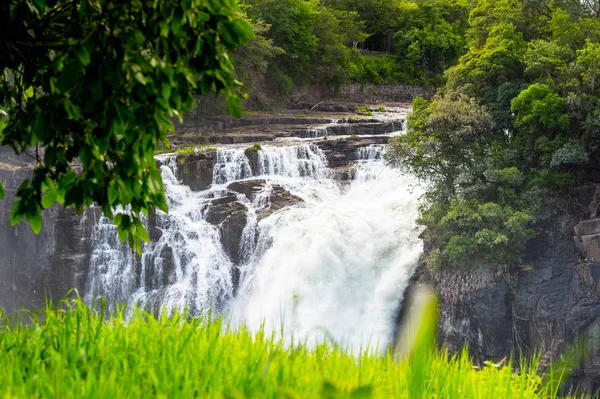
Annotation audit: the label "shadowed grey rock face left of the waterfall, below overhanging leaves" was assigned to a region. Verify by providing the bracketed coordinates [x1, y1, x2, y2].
[0, 164, 100, 312]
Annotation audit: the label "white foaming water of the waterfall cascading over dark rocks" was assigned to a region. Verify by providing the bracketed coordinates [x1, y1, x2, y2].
[86, 141, 422, 350]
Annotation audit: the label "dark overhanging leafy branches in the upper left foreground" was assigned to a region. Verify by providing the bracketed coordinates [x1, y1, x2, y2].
[0, 0, 252, 250]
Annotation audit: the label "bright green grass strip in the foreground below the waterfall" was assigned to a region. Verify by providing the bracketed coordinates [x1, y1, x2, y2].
[0, 300, 576, 399]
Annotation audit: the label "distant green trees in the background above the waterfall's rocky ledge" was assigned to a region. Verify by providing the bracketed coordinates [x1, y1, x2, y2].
[236, 0, 468, 94]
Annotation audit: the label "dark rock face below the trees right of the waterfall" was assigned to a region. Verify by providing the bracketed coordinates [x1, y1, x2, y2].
[414, 186, 600, 392]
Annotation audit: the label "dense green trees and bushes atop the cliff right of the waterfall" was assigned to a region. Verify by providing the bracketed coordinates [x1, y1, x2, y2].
[388, 0, 600, 268]
